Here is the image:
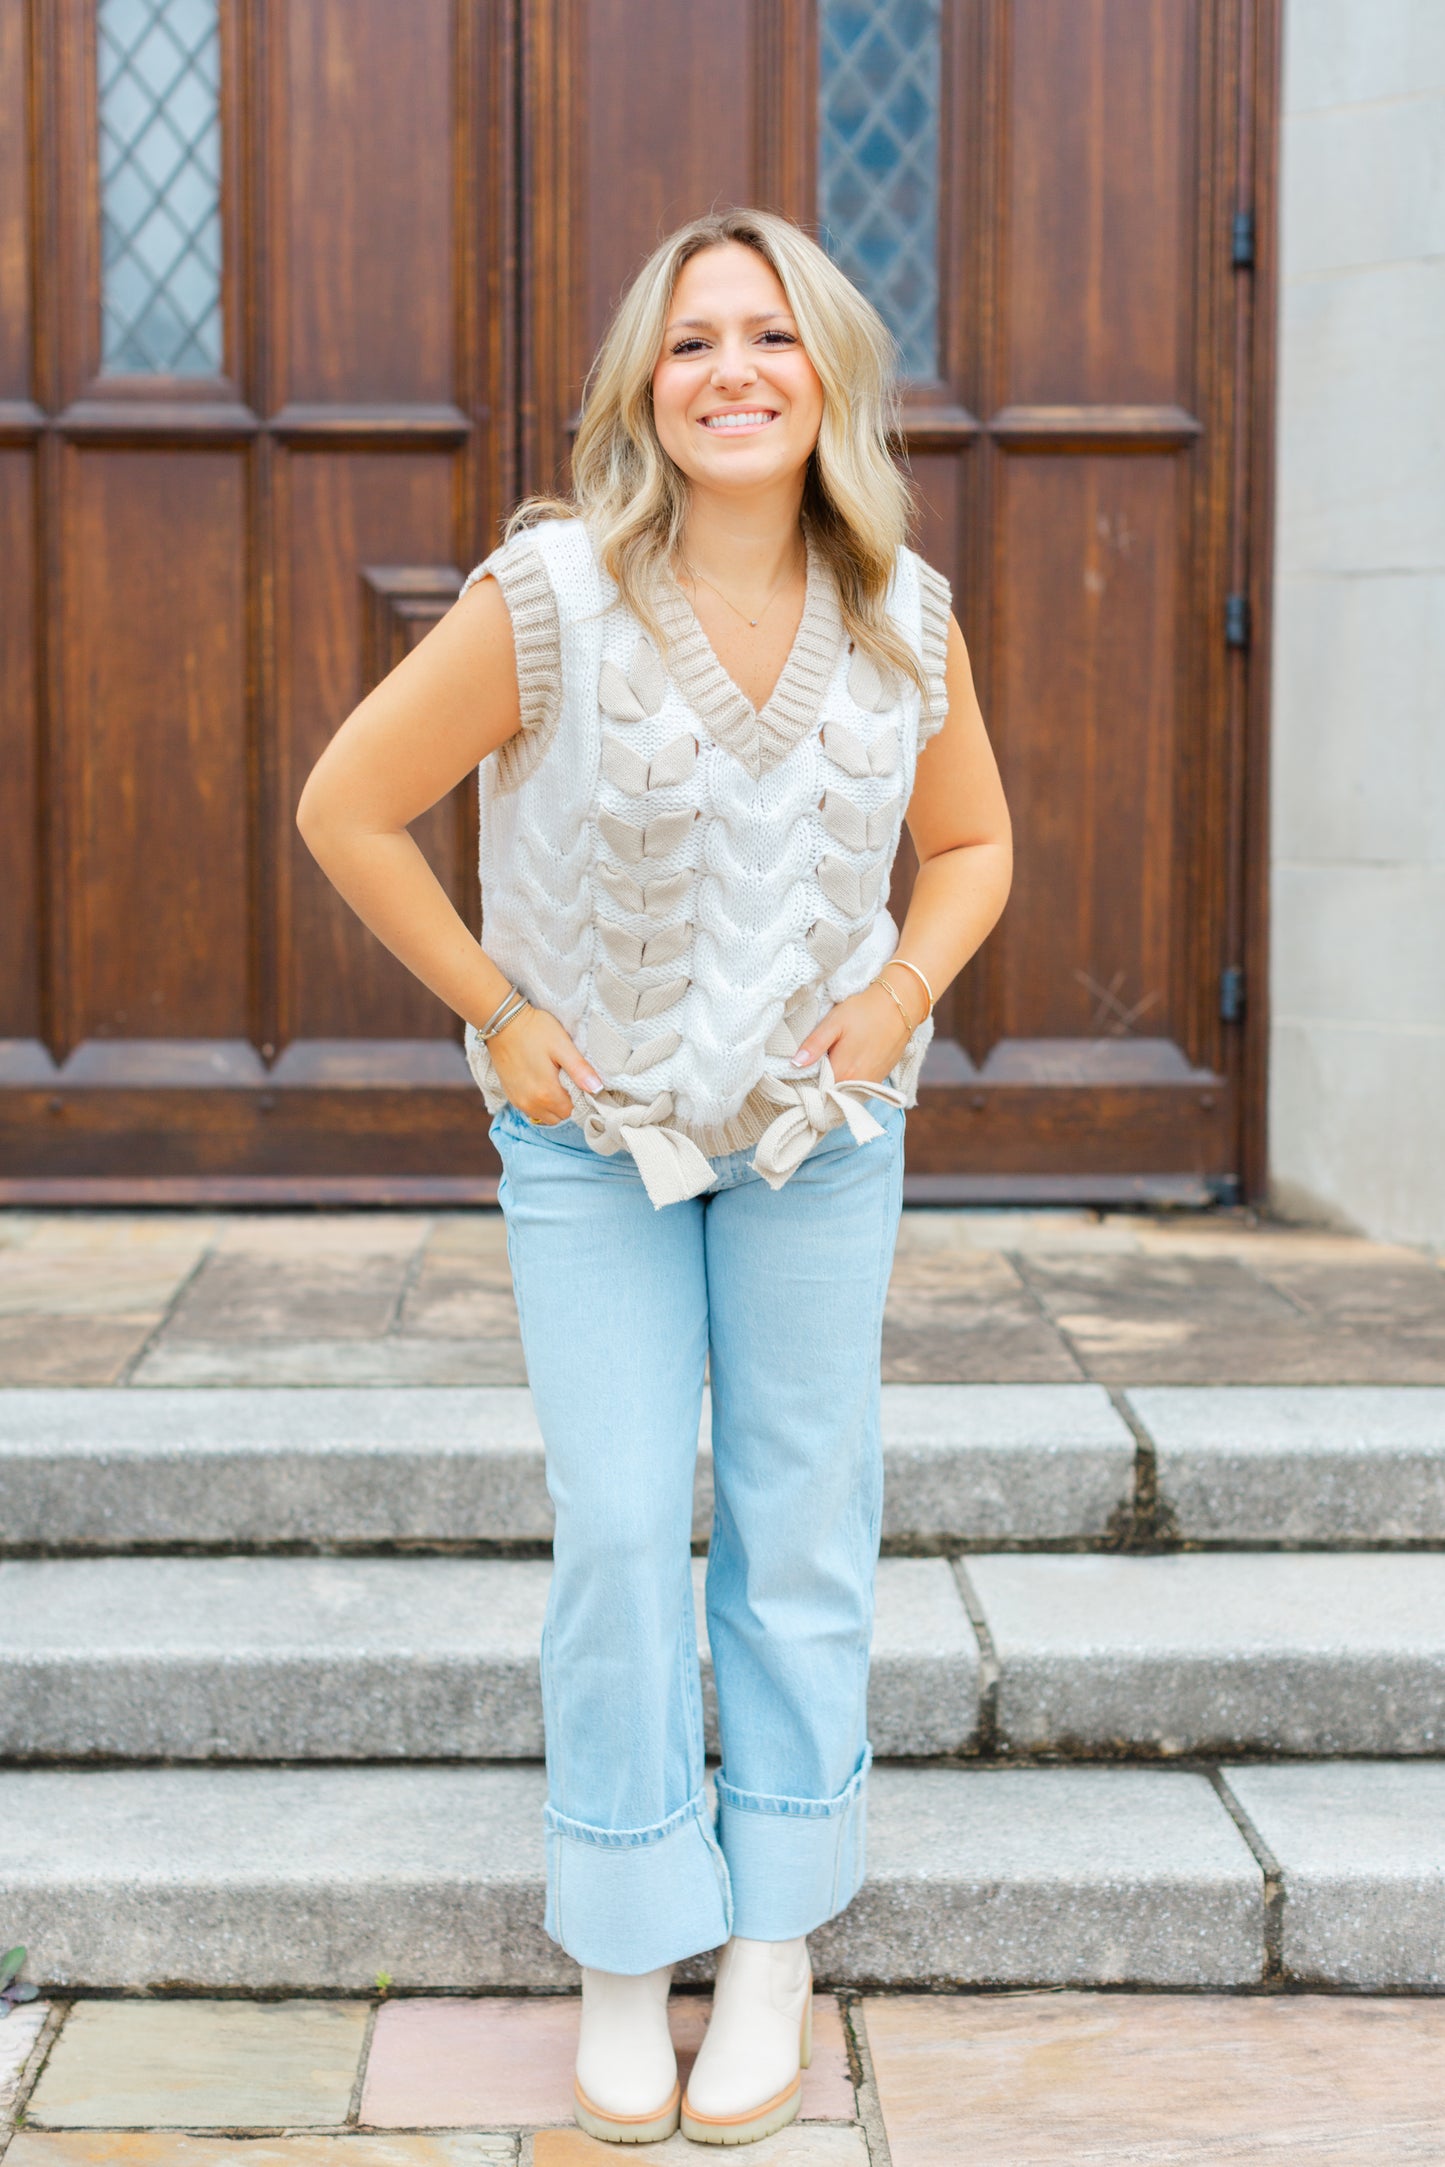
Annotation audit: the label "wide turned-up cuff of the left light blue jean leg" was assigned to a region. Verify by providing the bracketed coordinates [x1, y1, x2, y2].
[542, 1792, 732, 1972]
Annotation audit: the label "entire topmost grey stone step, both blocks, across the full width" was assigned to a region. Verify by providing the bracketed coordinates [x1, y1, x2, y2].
[0, 1385, 1445, 1549]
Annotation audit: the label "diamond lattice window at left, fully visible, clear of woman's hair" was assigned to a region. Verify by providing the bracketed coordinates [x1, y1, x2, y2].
[95, 0, 221, 377]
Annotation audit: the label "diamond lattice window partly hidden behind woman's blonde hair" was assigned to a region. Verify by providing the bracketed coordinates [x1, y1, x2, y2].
[819, 0, 940, 377]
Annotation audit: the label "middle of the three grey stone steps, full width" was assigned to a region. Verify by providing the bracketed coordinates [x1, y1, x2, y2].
[0, 1552, 1445, 1760]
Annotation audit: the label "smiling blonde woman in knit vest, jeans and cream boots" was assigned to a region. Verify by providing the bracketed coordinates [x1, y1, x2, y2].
[297, 210, 1010, 2143]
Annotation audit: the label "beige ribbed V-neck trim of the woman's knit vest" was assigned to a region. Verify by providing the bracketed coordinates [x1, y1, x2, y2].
[656, 531, 843, 776]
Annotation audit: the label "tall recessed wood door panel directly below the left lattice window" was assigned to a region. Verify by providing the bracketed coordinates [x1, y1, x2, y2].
[54, 446, 249, 1051]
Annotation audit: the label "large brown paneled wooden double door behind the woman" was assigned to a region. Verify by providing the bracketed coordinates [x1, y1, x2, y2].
[0, 0, 1276, 1201]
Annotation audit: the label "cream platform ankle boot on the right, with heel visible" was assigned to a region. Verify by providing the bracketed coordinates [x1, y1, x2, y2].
[682, 1935, 812, 2145]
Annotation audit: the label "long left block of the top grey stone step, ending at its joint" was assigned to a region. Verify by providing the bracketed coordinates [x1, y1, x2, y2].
[0, 1385, 1135, 1552]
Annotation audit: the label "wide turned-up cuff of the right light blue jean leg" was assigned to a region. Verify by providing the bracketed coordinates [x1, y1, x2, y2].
[717, 1744, 873, 1942]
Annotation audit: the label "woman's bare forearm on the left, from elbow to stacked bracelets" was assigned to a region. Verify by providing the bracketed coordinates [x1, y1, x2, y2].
[303, 823, 513, 1023]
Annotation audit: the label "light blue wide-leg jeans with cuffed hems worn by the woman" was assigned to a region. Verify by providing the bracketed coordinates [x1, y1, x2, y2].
[490, 1101, 906, 1972]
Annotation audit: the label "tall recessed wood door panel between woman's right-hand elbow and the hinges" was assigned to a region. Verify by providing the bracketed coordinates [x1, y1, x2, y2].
[990, 455, 1187, 1038]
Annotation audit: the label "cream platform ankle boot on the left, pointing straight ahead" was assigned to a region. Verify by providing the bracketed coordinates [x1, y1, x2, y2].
[572, 1963, 682, 2145]
